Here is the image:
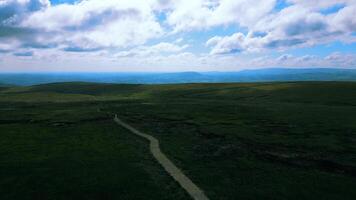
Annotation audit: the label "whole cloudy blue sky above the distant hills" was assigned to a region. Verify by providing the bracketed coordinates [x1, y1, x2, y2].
[0, 0, 356, 72]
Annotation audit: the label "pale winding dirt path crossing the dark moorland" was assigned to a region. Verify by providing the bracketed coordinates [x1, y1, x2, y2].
[114, 115, 208, 200]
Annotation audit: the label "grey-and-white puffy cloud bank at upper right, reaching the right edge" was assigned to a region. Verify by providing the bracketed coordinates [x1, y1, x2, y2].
[208, 0, 356, 54]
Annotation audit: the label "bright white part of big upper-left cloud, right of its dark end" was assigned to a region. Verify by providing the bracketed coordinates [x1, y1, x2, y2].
[21, 0, 163, 49]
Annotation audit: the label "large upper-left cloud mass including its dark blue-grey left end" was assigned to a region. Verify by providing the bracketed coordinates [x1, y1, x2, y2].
[0, 0, 163, 51]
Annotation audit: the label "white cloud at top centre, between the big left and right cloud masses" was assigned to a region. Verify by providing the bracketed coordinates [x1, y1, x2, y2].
[166, 0, 276, 32]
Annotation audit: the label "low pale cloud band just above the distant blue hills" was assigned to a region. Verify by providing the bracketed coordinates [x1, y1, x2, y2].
[0, 50, 356, 71]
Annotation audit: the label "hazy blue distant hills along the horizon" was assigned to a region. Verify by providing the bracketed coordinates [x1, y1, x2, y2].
[0, 68, 356, 85]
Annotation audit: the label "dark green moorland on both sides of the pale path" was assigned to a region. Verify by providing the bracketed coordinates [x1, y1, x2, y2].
[0, 82, 356, 200]
